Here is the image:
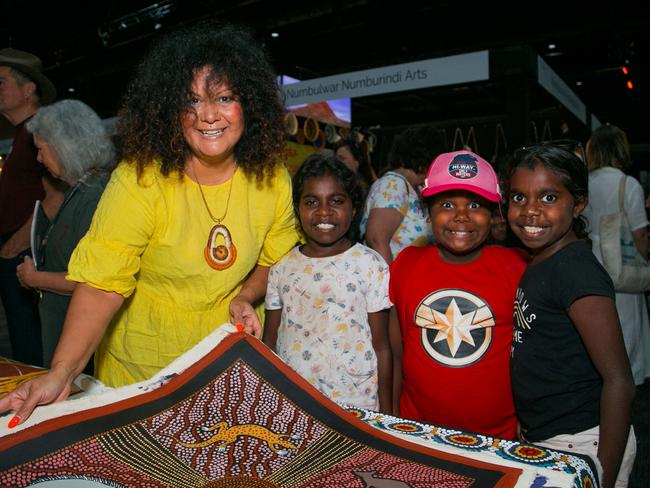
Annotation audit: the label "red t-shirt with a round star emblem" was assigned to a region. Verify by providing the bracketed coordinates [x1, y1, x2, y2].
[390, 246, 526, 439]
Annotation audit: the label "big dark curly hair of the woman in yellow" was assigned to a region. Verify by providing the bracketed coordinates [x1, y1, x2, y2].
[117, 22, 285, 181]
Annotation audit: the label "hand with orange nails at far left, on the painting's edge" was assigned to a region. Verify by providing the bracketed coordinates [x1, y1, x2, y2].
[0, 370, 72, 427]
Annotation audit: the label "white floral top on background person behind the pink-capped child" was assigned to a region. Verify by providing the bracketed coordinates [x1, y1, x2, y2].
[360, 171, 433, 259]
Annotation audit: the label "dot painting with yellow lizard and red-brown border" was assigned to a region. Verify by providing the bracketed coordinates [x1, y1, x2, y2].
[0, 333, 521, 488]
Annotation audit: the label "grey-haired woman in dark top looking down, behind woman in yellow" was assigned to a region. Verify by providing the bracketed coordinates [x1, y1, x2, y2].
[17, 100, 115, 367]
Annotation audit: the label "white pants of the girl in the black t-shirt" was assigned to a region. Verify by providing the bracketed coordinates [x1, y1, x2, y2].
[535, 426, 636, 488]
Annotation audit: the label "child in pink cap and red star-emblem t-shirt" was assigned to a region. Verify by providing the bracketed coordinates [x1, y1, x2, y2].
[390, 151, 526, 439]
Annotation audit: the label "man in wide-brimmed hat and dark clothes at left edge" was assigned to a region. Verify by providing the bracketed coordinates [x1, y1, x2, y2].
[0, 48, 56, 365]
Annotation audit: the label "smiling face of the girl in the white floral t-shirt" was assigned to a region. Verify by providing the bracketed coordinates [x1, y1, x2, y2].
[298, 174, 355, 257]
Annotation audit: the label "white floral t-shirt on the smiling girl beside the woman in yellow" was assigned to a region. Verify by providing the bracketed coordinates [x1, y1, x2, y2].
[265, 244, 391, 410]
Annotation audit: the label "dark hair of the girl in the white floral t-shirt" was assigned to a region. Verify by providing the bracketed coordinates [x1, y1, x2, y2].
[292, 153, 363, 242]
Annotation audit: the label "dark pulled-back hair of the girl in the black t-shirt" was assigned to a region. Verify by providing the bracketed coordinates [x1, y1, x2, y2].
[508, 143, 589, 239]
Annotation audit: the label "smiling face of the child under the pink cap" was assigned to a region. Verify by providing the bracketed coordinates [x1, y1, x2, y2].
[429, 190, 494, 263]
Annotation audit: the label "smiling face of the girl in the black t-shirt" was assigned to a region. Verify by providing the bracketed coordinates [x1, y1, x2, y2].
[508, 164, 586, 263]
